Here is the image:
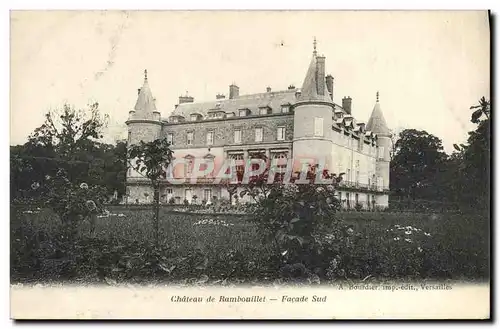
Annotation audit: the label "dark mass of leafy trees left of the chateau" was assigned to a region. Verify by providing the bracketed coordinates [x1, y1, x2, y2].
[10, 103, 127, 201]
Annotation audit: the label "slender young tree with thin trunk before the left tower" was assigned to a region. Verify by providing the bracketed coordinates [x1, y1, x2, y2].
[128, 138, 173, 246]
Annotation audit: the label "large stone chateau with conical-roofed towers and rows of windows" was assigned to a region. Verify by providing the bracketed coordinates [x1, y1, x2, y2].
[126, 41, 391, 208]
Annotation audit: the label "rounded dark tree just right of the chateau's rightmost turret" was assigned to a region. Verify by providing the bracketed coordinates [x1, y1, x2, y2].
[390, 129, 447, 199]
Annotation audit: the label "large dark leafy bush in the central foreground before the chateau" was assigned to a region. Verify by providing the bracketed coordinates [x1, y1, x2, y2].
[244, 167, 344, 277]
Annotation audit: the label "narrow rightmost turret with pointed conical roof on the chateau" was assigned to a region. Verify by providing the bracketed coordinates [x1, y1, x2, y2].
[366, 91, 392, 207]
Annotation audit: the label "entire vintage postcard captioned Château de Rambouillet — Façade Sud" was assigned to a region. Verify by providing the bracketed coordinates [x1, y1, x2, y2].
[9, 10, 491, 320]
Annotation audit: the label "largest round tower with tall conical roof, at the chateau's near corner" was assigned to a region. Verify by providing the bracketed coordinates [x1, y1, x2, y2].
[293, 39, 334, 177]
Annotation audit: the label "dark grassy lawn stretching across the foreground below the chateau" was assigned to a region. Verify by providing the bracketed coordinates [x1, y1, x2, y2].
[11, 206, 489, 281]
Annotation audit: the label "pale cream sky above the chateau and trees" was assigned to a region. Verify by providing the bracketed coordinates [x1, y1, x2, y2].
[10, 11, 490, 152]
